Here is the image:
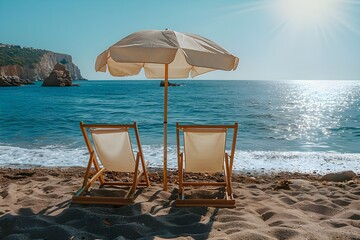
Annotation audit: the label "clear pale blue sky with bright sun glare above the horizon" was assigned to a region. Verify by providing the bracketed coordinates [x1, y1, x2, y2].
[0, 0, 360, 80]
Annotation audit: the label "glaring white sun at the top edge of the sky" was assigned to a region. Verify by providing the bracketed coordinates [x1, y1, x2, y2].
[276, 0, 341, 27]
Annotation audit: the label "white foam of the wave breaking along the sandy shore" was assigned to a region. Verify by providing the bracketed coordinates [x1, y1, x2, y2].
[0, 145, 360, 174]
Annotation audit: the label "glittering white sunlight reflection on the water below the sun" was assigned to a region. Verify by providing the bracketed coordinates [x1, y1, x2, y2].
[276, 81, 355, 144]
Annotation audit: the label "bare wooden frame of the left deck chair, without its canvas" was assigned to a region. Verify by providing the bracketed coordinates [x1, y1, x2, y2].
[72, 122, 150, 205]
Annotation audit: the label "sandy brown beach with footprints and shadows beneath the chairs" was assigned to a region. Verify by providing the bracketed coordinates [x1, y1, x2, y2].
[0, 168, 360, 240]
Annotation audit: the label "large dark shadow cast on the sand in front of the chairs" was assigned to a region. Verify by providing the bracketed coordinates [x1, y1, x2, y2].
[0, 188, 219, 240]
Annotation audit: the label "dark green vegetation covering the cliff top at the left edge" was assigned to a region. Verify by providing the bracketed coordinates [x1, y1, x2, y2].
[0, 43, 47, 68]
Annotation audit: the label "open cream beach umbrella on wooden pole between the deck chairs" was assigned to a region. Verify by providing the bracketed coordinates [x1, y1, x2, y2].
[95, 30, 239, 190]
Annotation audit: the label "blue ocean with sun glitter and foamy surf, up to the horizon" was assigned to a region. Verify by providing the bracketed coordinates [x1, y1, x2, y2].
[0, 80, 360, 174]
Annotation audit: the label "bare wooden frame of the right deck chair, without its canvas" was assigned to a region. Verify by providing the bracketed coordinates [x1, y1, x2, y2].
[176, 123, 238, 208]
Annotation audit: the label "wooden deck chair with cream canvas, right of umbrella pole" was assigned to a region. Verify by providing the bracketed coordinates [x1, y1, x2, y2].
[176, 123, 238, 208]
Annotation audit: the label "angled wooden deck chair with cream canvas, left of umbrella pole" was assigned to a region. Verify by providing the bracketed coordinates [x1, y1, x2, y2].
[72, 122, 150, 205]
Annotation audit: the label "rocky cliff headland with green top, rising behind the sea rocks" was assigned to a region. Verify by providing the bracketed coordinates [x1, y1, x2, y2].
[0, 43, 83, 80]
